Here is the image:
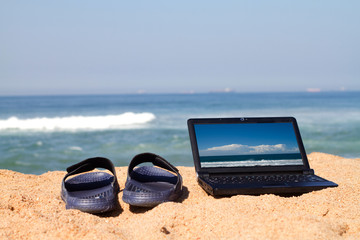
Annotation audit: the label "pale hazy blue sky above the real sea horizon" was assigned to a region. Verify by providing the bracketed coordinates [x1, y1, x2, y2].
[0, 0, 360, 95]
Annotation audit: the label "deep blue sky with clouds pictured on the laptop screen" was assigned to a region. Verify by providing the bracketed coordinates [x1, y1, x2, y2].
[194, 123, 299, 156]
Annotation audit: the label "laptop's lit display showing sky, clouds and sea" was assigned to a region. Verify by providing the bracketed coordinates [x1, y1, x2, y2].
[194, 122, 303, 168]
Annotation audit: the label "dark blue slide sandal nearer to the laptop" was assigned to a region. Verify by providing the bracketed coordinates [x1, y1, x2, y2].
[122, 153, 182, 207]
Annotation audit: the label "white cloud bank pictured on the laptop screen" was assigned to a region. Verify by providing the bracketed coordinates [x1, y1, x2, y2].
[200, 144, 299, 156]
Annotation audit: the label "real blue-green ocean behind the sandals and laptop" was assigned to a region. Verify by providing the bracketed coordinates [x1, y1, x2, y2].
[0, 91, 360, 174]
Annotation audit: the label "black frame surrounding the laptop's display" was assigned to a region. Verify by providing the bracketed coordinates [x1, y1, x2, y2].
[187, 117, 310, 173]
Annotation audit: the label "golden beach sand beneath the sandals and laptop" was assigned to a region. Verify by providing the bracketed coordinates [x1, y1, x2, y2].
[0, 153, 360, 239]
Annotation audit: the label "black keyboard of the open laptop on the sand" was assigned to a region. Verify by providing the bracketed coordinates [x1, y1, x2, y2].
[205, 174, 324, 184]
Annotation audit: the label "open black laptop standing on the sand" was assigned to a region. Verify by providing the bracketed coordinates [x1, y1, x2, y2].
[187, 117, 338, 196]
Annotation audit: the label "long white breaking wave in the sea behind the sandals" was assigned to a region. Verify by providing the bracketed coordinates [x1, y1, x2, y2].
[0, 112, 156, 131]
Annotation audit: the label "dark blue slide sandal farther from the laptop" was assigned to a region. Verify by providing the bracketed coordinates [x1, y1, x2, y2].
[61, 157, 120, 213]
